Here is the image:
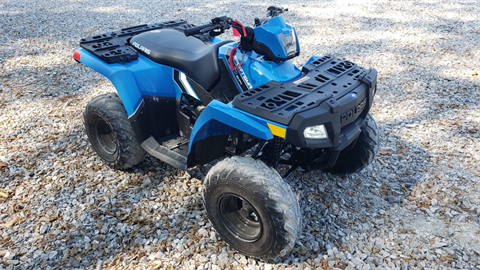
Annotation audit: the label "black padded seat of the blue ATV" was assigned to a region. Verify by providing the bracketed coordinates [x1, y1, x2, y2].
[130, 29, 232, 91]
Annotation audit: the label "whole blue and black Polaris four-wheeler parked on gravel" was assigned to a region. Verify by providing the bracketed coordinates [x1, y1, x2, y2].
[74, 7, 378, 259]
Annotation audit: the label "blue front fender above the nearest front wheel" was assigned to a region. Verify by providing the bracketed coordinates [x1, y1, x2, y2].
[190, 100, 273, 151]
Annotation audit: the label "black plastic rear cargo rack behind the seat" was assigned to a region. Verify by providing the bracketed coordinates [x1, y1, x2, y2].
[80, 20, 194, 64]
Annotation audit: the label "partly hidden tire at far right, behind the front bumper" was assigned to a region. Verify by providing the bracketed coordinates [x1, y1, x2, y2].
[324, 114, 379, 175]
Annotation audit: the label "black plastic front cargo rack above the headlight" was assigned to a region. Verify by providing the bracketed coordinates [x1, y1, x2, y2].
[233, 55, 376, 125]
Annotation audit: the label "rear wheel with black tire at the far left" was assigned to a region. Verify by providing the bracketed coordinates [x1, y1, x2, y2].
[83, 93, 146, 170]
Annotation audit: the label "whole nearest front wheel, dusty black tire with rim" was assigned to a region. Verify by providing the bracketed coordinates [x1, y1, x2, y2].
[203, 157, 301, 259]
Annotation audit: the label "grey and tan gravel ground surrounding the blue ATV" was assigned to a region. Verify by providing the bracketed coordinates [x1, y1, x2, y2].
[0, 0, 480, 269]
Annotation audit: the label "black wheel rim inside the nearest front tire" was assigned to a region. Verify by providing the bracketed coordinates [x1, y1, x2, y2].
[218, 194, 262, 242]
